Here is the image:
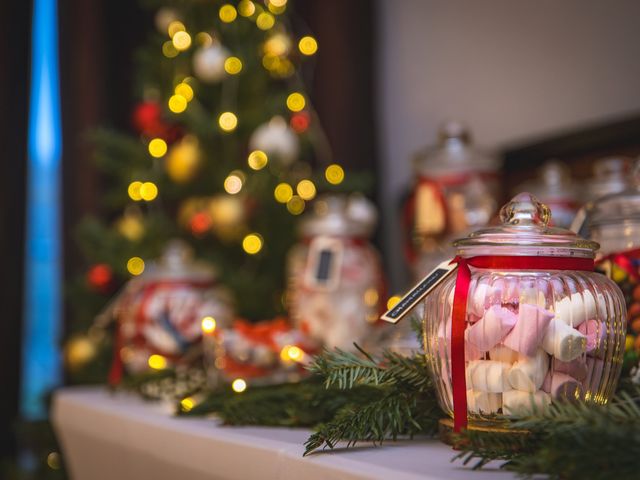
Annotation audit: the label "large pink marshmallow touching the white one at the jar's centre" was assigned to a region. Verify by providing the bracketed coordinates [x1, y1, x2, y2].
[502, 303, 553, 357]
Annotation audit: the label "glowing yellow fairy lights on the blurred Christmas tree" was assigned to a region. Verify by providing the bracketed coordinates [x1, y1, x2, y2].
[121, 0, 345, 276]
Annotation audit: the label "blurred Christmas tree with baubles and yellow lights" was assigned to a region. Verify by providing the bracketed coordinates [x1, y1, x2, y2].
[66, 0, 370, 378]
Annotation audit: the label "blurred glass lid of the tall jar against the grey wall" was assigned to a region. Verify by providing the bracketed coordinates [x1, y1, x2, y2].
[415, 121, 500, 177]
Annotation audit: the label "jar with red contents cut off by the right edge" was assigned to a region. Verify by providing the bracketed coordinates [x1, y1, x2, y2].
[585, 162, 640, 365]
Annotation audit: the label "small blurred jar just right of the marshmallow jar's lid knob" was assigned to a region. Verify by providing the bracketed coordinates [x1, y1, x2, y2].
[516, 160, 580, 228]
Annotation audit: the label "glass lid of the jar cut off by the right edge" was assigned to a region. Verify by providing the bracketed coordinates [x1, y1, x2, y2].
[587, 160, 640, 228]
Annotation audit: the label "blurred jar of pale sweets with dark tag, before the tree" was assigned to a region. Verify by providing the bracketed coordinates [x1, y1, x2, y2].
[287, 194, 386, 350]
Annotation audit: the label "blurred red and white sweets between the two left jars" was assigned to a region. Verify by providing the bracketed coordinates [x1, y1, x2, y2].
[202, 317, 319, 391]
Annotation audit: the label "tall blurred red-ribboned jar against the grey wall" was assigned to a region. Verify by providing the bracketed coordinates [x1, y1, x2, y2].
[403, 122, 500, 277]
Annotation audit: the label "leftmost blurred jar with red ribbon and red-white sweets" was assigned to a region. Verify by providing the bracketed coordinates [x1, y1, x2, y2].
[102, 241, 234, 383]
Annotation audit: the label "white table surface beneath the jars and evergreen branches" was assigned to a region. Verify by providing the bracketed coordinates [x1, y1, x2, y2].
[52, 387, 515, 480]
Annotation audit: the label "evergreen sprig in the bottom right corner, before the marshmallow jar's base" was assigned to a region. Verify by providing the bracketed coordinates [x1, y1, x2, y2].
[457, 387, 640, 480]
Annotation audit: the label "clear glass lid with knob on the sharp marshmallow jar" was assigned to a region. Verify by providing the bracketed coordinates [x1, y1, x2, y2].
[453, 192, 600, 258]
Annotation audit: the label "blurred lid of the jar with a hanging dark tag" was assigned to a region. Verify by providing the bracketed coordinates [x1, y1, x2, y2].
[300, 194, 378, 237]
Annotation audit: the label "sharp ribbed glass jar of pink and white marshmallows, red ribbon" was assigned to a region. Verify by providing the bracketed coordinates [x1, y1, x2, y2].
[423, 193, 626, 425]
